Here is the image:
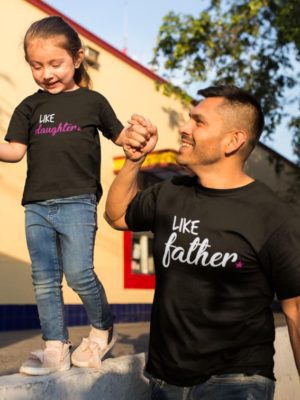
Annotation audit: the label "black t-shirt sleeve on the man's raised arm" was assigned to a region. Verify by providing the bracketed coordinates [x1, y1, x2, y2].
[125, 184, 160, 232]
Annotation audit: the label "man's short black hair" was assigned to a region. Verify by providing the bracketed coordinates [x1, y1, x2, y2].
[198, 85, 264, 143]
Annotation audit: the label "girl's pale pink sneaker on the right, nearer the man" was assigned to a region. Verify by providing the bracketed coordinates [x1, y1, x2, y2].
[71, 327, 118, 370]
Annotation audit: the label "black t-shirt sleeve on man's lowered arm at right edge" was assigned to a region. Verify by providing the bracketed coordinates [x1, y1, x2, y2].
[260, 216, 300, 300]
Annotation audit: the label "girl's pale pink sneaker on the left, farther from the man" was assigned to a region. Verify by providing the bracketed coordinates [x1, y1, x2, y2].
[20, 340, 71, 375]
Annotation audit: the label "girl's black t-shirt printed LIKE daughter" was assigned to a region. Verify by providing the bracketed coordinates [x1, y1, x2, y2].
[5, 88, 123, 204]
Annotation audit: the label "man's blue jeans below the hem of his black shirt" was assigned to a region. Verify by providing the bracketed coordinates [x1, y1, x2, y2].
[150, 374, 275, 400]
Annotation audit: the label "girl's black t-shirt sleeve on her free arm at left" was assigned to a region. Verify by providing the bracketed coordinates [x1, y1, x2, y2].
[5, 101, 30, 145]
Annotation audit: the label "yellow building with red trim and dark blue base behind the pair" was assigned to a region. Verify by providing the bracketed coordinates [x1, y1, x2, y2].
[0, 0, 299, 330]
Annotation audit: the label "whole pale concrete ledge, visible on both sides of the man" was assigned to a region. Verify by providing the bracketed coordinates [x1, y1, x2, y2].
[0, 327, 300, 400]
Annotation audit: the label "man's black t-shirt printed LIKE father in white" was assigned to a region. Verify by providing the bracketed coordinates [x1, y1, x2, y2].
[126, 177, 300, 386]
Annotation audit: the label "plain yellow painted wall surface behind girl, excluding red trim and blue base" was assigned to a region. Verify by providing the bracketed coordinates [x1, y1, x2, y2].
[0, 0, 187, 304]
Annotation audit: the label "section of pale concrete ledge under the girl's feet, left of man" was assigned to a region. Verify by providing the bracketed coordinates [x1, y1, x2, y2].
[0, 353, 150, 400]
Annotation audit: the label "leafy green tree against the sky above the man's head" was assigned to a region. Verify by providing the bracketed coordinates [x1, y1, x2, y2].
[152, 0, 300, 163]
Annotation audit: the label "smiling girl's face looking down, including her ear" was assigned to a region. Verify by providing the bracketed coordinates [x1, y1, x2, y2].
[26, 36, 84, 94]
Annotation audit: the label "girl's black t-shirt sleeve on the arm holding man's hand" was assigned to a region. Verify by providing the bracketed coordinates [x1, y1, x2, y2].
[98, 96, 124, 140]
